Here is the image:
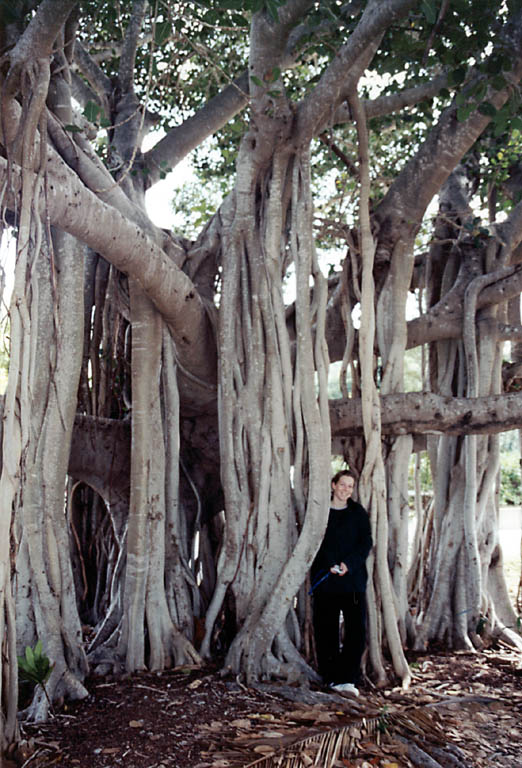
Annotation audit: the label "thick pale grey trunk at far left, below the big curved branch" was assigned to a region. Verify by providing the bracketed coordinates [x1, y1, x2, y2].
[10, 233, 87, 720]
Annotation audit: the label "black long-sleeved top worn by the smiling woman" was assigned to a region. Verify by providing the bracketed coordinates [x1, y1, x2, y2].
[311, 499, 372, 595]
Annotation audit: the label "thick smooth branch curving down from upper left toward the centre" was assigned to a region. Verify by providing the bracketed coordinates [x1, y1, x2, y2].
[0, 154, 217, 408]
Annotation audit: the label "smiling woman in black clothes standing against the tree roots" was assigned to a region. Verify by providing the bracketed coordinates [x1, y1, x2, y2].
[311, 470, 372, 696]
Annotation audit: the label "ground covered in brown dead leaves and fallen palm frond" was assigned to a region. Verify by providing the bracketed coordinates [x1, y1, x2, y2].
[10, 646, 522, 768]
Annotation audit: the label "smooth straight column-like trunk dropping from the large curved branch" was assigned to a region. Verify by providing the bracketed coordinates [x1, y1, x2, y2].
[118, 282, 199, 672]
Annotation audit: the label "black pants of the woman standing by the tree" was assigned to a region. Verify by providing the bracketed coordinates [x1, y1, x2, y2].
[314, 592, 366, 684]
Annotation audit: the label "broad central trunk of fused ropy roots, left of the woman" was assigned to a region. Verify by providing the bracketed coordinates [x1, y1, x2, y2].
[199, 137, 330, 680]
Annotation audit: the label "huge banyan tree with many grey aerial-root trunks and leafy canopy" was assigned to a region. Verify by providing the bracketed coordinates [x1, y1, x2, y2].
[0, 0, 522, 746]
